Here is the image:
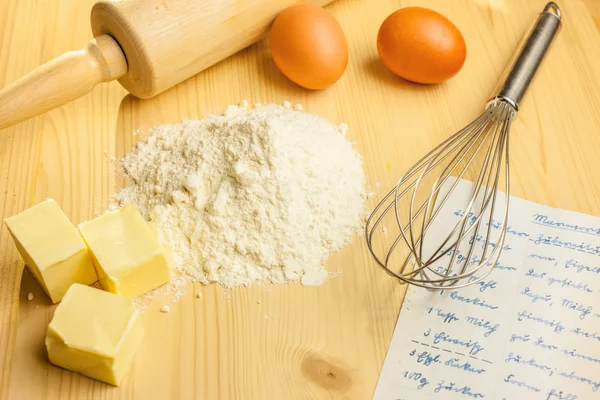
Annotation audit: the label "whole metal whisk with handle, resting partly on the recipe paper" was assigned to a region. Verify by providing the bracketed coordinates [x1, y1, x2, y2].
[365, 2, 561, 289]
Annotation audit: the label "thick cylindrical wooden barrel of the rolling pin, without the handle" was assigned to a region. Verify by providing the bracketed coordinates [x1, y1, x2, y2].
[91, 0, 332, 99]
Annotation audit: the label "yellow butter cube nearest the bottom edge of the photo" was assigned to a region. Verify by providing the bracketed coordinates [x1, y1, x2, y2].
[46, 284, 144, 386]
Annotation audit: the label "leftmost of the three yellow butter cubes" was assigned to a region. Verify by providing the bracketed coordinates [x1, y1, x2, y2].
[4, 199, 98, 303]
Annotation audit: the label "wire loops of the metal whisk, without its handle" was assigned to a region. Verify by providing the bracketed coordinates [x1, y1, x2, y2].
[365, 100, 515, 289]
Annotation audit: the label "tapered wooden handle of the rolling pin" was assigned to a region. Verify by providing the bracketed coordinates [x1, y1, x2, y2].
[0, 35, 127, 129]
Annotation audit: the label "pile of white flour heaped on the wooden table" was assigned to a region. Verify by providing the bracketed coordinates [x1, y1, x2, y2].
[113, 104, 365, 287]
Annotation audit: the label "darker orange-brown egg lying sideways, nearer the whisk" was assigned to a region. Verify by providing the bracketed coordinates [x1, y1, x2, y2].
[377, 7, 467, 83]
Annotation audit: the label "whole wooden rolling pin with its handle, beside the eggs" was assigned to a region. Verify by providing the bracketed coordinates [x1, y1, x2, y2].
[0, 0, 332, 129]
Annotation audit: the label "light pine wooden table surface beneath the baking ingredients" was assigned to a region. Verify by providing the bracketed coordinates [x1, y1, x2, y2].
[0, 0, 600, 400]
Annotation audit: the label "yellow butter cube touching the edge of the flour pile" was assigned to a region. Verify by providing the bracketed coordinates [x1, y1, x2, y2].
[79, 204, 171, 297]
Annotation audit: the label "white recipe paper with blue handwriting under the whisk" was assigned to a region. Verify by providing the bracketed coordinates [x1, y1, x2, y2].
[373, 181, 600, 400]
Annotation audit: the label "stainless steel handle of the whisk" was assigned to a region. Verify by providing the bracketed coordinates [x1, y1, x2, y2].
[490, 2, 562, 111]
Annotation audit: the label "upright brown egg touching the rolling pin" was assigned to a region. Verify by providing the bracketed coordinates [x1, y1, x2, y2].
[269, 4, 348, 90]
